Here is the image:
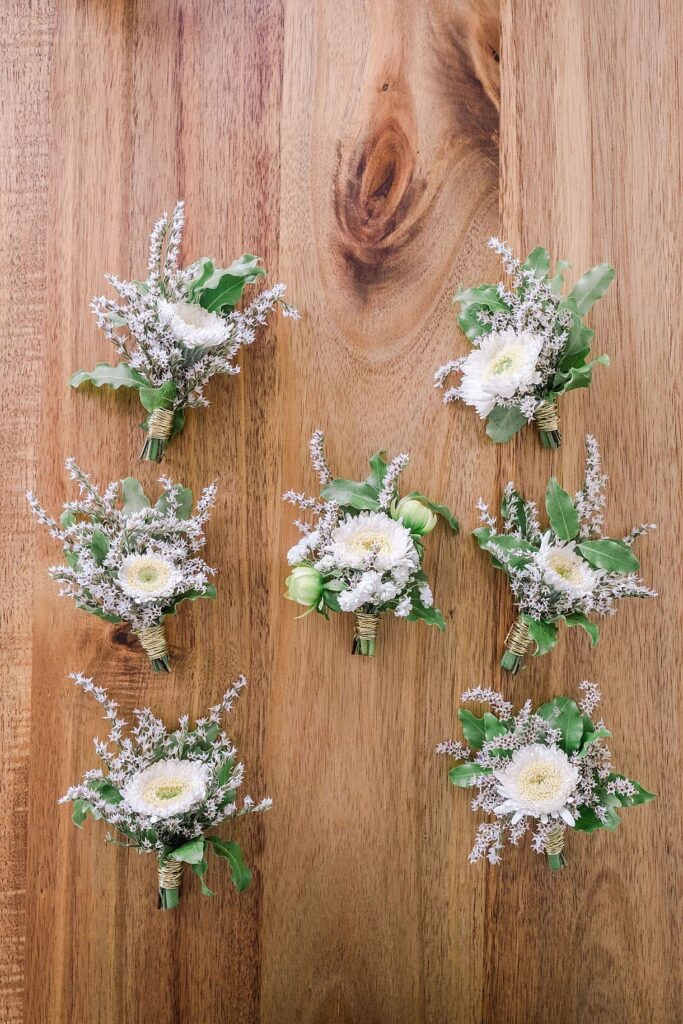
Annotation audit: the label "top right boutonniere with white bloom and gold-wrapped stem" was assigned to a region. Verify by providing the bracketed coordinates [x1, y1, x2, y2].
[434, 239, 614, 449]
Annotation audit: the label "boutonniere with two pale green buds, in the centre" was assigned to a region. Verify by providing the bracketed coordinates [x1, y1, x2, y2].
[284, 430, 459, 656]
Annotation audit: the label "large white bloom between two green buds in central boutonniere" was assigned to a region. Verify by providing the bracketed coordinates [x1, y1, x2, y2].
[327, 512, 420, 572]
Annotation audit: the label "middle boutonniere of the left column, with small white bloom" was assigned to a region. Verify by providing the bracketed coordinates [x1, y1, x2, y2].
[27, 459, 216, 672]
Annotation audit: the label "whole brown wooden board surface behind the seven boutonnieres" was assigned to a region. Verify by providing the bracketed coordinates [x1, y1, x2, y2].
[0, 0, 683, 1024]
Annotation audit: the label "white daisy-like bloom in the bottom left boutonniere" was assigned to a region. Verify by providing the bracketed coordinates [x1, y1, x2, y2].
[121, 758, 209, 821]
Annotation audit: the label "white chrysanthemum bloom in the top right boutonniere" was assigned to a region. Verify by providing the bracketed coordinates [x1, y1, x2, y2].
[458, 328, 544, 419]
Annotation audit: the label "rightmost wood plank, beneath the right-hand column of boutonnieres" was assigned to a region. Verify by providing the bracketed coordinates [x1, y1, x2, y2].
[493, 0, 683, 1024]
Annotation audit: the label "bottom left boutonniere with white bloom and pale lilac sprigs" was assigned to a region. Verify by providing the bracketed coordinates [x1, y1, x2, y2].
[59, 673, 272, 910]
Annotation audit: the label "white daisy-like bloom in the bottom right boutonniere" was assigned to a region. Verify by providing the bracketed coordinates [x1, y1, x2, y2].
[494, 743, 579, 827]
